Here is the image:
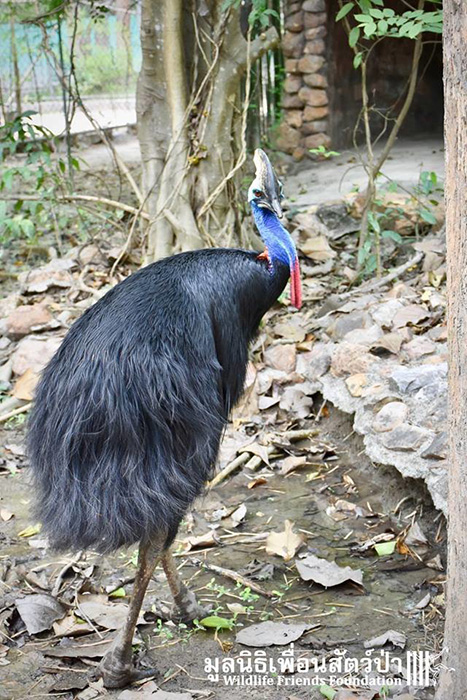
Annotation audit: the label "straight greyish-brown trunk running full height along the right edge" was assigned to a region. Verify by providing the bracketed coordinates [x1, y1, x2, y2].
[436, 0, 467, 700]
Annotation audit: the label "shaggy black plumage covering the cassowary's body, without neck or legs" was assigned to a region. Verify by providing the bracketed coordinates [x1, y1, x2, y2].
[29, 250, 289, 552]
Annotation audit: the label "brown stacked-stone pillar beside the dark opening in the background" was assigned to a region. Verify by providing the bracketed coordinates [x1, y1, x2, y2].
[277, 0, 331, 160]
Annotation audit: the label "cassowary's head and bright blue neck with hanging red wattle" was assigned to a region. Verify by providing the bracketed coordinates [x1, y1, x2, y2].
[248, 148, 302, 309]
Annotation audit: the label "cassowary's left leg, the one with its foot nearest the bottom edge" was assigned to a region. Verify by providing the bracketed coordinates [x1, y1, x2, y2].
[99, 542, 162, 688]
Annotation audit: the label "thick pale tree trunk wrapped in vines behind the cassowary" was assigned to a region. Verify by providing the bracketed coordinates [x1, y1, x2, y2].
[137, 0, 279, 262]
